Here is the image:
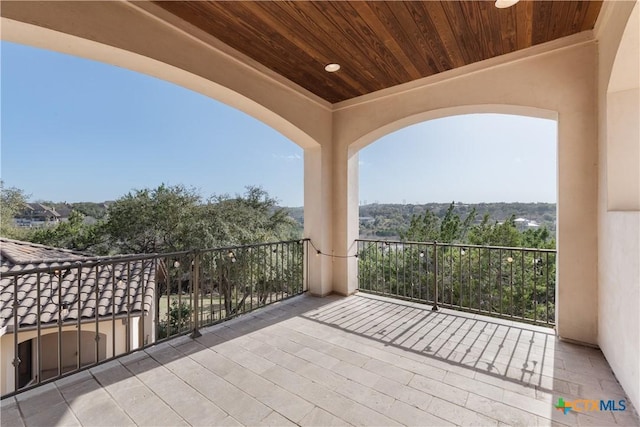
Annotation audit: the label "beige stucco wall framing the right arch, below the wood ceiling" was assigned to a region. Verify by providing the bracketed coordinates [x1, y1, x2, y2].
[333, 40, 598, 344]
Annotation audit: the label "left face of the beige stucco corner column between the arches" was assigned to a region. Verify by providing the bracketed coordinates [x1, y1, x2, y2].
[304, 144, 332, 296]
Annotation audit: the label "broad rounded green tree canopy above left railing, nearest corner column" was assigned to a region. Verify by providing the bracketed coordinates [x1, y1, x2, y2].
[104, 184, 296, 253]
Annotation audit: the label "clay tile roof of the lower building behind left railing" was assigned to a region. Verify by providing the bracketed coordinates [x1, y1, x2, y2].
[0, 238, 156, 335]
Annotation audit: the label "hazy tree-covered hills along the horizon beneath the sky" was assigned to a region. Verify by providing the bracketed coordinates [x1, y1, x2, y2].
[286, 203, 556, 239]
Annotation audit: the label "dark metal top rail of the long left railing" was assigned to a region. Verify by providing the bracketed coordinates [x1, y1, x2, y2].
[0, 239, 309, 278]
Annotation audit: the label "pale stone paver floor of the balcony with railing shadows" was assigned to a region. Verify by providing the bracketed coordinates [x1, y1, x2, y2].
[5, 294, 639, 427]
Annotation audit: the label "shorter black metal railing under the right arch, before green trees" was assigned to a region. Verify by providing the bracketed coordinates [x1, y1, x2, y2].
[356, 239, 556, 326]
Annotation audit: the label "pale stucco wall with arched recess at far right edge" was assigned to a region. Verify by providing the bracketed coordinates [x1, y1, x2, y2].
[596, 2, 640, 409]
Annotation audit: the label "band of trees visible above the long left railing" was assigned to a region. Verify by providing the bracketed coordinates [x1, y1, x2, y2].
[0, 184, 301, 255]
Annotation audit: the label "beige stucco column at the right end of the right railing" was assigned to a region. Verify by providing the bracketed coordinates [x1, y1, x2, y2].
[556, 109, 598, 344]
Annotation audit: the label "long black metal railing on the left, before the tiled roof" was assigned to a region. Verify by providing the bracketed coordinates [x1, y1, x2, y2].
[0, 240, 308, 397]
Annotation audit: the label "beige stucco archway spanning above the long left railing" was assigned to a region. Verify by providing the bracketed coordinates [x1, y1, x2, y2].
[2, 2, 332, 295]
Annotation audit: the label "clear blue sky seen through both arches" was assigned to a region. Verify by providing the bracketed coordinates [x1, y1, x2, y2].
[0, 42, 557, 206]
